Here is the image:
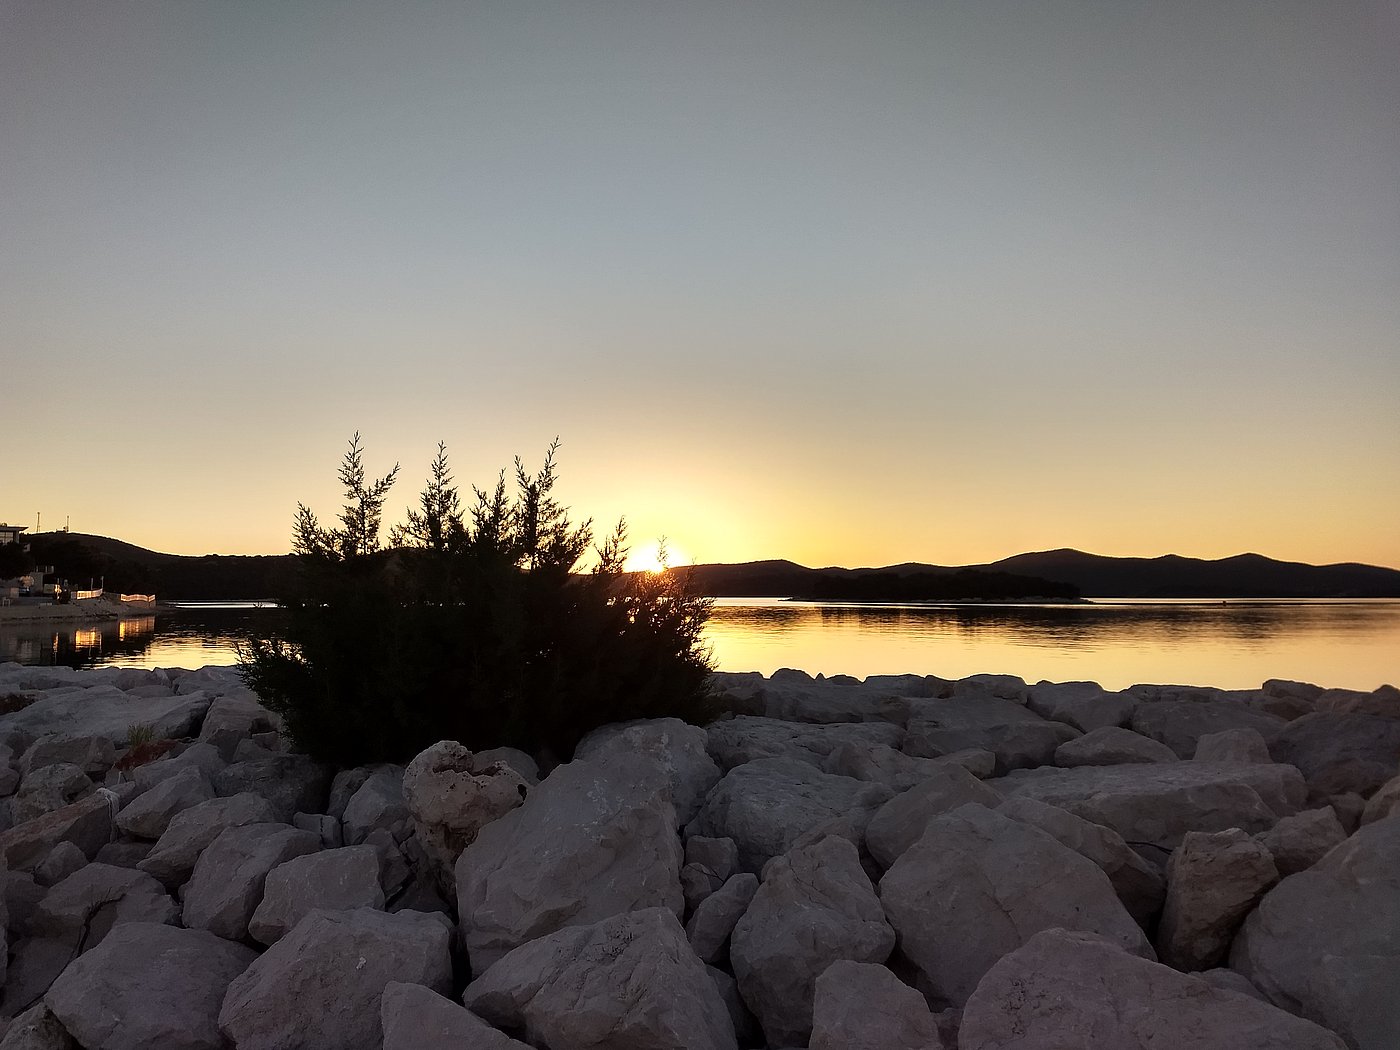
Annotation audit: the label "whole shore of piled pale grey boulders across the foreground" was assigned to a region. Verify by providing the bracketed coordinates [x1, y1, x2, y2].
[0, 664, 1400, 1050]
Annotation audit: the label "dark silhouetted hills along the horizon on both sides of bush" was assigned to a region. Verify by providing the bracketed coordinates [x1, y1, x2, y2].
[13, 532, 1400, 602]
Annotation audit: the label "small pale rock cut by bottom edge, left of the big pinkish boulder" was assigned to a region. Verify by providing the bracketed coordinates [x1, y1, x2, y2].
[808, 960, 944, 1050]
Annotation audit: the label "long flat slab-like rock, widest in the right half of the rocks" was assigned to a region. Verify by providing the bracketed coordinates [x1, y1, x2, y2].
[988, 762, 1308, 850]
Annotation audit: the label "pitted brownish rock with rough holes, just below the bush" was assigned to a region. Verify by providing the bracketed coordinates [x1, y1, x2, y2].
[403, 741, 533, 893]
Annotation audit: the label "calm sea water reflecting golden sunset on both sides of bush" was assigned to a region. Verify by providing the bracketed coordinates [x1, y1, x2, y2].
[0, 599, 1400, 689]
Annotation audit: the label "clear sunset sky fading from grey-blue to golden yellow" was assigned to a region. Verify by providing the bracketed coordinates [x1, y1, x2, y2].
[0, 0, 1400, 567]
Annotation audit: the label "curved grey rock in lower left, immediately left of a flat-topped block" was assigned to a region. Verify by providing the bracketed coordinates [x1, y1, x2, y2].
[183, 823, 321, 941]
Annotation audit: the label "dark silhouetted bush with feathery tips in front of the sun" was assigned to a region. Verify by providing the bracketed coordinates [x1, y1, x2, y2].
[242, 434, 710, 766]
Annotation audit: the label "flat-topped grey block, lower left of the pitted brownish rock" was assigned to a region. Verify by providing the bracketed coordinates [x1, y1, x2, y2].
[248, 846, 384, 944]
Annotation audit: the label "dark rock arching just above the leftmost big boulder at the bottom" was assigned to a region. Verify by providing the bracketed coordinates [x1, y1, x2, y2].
[29, 864, 179, 951]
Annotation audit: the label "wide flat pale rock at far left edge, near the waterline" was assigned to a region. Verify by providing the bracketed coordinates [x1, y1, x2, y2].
[6, 685, 211, 746]
